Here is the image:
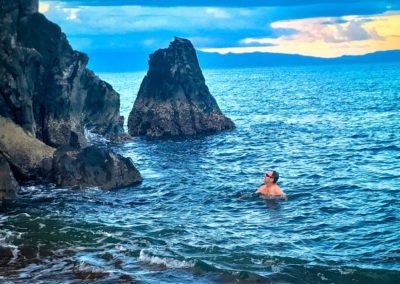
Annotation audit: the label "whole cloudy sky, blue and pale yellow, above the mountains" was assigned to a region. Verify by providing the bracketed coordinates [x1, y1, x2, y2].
[39, 0, 400, 58]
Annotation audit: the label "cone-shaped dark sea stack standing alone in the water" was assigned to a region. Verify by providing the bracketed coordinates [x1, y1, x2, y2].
[128, 37, 235, 137]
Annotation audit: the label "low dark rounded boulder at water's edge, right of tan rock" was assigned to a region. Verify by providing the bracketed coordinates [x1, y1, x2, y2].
[52, 146, 142, 189]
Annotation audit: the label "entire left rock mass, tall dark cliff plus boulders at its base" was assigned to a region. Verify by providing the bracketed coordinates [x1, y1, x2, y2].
[0, 0, 141, 202]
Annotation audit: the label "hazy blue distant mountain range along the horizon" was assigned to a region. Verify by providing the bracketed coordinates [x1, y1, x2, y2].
[88, 50, 400, 72]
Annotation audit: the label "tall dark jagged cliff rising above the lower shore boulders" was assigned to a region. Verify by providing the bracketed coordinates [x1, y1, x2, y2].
[0, 0, 123, 147]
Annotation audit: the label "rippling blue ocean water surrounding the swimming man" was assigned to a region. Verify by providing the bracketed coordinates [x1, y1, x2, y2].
[0, 64, 400, 283]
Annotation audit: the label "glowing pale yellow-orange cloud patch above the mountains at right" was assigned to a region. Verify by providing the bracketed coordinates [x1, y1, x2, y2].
[201, 11, 400, 58]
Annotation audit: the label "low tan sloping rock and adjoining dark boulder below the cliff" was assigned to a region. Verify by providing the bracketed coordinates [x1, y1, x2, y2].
[0, 116, 142, 191]
